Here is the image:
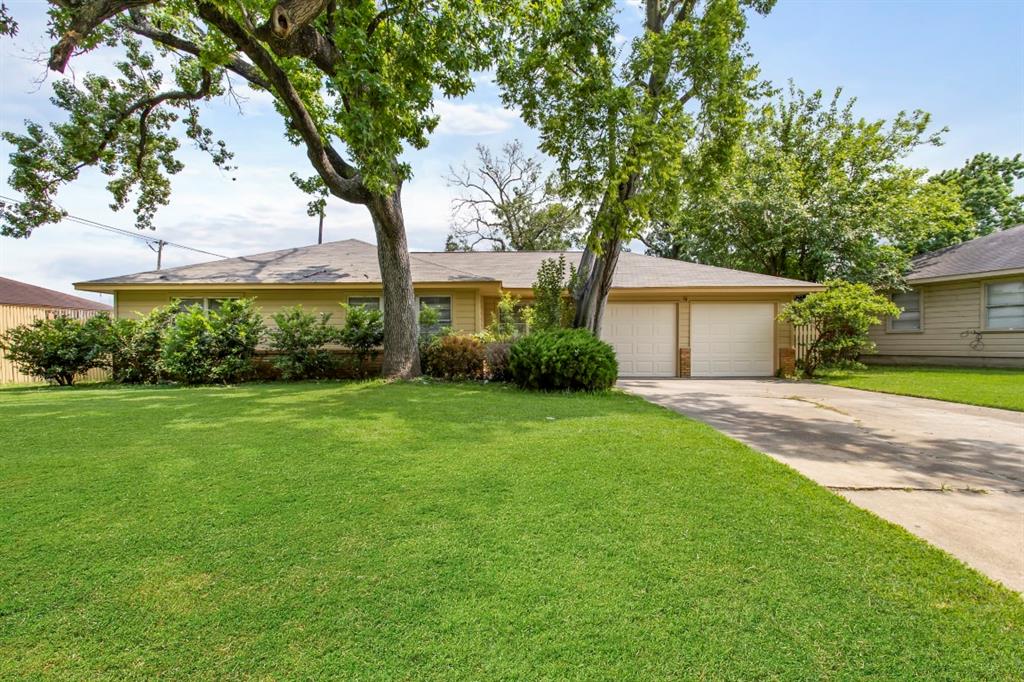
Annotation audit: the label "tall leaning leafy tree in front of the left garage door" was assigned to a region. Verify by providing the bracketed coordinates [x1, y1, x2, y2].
[498, 0, 773, 332]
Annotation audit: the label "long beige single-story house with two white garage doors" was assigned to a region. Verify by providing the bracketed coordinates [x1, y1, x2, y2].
[75, 240, 820, 377]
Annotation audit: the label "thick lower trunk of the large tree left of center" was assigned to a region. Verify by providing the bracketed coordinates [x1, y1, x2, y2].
[368, 185, 420, 379]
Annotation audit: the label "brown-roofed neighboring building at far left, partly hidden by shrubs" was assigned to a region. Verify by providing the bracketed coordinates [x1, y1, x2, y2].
[0, 278, 111, 384]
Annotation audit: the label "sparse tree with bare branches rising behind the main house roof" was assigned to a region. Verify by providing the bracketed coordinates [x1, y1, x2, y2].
[445, 140, 583, 251]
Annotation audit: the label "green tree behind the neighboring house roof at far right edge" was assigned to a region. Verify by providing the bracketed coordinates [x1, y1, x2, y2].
[913, 154, 1024, 253]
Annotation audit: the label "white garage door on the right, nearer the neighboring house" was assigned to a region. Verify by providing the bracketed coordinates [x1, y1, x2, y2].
[690, 303, 775, 377]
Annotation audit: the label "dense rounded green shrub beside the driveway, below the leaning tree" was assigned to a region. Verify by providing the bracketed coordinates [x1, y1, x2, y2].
[509, 329, 618, 391]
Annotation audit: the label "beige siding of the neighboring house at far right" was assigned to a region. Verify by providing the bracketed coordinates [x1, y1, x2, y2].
[866, 275, 1024, 365]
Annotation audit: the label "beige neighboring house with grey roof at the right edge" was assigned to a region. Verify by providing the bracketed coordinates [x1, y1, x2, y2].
[864, 225, 1024, 367]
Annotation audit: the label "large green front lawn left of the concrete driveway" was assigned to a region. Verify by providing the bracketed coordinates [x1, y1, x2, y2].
[0, 383, 1024, 680]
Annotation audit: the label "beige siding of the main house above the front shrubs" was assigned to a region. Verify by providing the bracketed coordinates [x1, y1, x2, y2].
[115, 288, 479, 333]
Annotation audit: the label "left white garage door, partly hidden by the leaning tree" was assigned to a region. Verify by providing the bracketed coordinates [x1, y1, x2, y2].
[601, 303, 679, 377]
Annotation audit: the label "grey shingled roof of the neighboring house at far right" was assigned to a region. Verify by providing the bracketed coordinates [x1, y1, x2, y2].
[906, 225, 1024, 282]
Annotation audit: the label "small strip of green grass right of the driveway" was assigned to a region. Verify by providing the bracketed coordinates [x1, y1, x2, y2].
[819, 366, 1024, 411]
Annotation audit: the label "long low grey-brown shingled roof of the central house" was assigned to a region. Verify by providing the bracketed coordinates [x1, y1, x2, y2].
[78, 240, 816, 290]
